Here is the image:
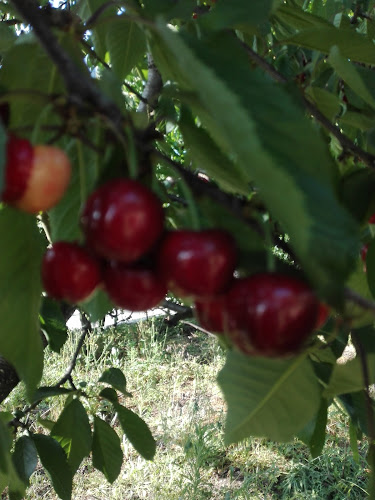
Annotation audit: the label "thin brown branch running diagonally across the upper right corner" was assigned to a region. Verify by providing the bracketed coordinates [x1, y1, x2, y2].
[240, 41, 375, 168]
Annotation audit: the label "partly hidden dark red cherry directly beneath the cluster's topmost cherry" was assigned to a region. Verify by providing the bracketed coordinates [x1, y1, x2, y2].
[103, 261, 167, 311]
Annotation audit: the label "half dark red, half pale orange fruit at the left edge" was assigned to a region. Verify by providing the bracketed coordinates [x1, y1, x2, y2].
[1, 136, 71, 214]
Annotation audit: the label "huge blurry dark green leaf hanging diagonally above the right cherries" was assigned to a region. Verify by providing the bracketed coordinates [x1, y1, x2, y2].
[152, 24, 359, 300]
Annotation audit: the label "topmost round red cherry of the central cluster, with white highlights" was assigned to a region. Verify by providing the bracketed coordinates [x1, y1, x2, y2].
[81, 179, 164, 263]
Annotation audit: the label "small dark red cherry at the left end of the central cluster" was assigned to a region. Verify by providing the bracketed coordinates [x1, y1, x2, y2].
[42, 241, 101, 304]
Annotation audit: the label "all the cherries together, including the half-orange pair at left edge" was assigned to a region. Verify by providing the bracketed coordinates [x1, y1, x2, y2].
[1, 137, 328, 356]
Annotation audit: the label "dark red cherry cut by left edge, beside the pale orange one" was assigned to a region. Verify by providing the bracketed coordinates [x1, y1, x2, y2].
[1, 135, 34, 203]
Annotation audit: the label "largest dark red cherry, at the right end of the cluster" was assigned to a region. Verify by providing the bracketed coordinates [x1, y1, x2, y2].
[227, 273, 319, 356]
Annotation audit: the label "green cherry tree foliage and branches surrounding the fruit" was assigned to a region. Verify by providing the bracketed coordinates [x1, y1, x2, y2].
[0, 0, 375, 499]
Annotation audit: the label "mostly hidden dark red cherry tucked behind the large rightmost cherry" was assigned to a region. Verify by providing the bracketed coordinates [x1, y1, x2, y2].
[195, 295, 228, 333]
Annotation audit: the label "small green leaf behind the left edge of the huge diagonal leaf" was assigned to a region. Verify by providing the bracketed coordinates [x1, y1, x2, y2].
[179, 107, 249, 194]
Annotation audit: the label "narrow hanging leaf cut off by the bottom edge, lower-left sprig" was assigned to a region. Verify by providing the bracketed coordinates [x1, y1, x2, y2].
[32, 434, 73, 500]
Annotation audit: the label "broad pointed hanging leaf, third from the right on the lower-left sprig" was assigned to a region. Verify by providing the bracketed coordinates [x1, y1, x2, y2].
[51, 399, 92, 474]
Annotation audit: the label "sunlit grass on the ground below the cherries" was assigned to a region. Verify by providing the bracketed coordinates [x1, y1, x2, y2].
[4, 319, 367, 500]
